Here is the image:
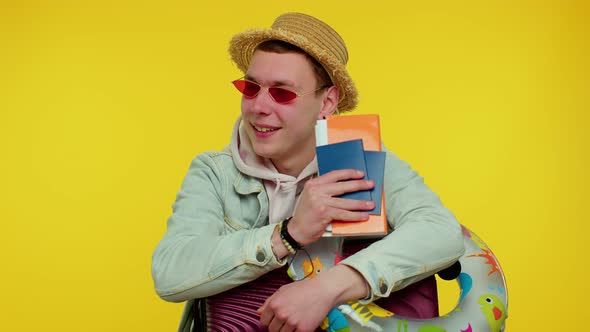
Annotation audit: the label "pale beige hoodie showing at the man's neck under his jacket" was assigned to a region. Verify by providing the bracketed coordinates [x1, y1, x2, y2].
[230, 117, 318, 224]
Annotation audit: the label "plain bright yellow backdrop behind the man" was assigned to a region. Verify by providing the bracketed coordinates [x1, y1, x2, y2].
[0, 0, 590, 331]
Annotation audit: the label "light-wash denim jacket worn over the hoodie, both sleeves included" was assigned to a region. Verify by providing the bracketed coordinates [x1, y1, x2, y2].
[152, 148, 464, 330]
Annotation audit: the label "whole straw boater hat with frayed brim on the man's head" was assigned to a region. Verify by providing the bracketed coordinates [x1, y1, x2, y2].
[229, 13, 358, 112]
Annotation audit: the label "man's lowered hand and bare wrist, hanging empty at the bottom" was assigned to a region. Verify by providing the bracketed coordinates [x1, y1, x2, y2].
[258, 265, 368, 332]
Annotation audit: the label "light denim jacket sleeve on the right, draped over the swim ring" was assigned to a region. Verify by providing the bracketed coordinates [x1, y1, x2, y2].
[341, 149, 465, 302]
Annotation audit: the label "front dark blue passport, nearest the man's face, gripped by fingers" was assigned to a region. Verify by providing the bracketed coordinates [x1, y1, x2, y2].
[316, 139, 371, 201]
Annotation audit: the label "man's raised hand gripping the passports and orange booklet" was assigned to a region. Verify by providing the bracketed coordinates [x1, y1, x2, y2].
[289, 169, 375, 246]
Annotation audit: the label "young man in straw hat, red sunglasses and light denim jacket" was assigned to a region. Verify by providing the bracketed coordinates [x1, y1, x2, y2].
[152, 13, 463, 331]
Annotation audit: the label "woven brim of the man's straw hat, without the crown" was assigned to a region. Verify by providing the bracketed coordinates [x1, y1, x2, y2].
[229, 28, 358, 112]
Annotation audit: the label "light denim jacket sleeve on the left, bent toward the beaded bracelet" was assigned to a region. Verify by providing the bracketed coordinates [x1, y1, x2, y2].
[152, 153, 285, 302]
